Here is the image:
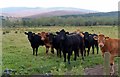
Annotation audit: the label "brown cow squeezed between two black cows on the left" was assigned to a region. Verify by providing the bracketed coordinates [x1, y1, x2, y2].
[38, 32, 54, 54]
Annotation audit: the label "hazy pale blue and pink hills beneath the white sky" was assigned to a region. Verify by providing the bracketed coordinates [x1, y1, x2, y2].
[0, 7, 96, 17]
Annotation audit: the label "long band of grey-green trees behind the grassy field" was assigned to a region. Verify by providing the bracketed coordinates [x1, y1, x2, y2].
[2, 11, 118, 27]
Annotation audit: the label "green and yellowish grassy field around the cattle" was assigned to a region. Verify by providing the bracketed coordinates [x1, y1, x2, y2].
[2, 26, 118, 75]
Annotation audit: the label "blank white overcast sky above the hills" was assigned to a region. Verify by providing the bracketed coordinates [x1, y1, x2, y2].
[0, 0, 120, 12]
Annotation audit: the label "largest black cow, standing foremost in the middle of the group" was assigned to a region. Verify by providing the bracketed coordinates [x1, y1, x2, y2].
[56, 29, 84, 64]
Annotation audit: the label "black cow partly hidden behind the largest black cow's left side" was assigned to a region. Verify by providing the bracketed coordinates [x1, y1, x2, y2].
[47, 33, 61, 58]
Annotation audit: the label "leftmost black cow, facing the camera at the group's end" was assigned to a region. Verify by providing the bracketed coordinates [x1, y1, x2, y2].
[25, 32, 44, 56]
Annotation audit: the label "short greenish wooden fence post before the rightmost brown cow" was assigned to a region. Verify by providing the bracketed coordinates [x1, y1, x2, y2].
[104, 52, 110, 75]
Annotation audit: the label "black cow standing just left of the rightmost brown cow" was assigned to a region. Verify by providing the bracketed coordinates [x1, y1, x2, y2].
[83, 32, 98, 56]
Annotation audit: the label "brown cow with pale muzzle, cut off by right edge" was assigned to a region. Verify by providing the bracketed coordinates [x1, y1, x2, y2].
[95, 34, 120, 74]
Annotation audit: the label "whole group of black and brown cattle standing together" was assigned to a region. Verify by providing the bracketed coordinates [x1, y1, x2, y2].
[25, 29, 120, 74]
